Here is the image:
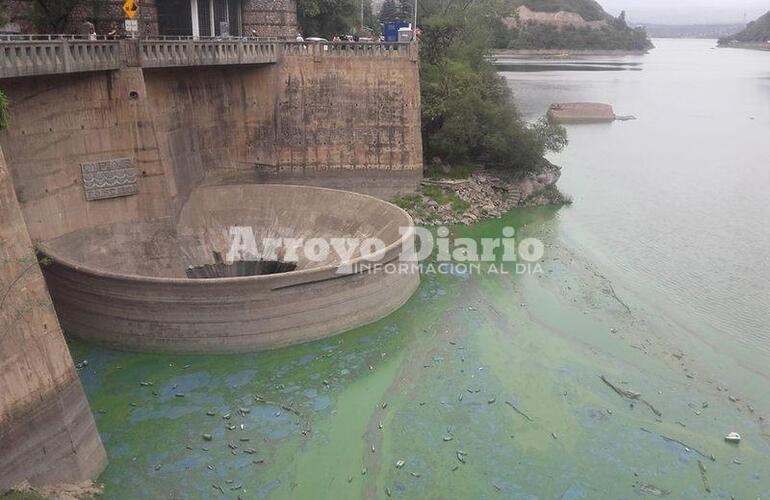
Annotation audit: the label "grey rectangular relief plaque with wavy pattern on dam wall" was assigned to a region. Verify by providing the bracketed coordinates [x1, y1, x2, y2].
[80, 158, 139, 201]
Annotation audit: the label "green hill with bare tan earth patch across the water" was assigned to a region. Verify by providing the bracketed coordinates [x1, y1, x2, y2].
[495, 0, 652, 51]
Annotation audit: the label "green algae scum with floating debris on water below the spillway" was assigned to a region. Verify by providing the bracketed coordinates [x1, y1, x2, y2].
[71, 209, 770, 499]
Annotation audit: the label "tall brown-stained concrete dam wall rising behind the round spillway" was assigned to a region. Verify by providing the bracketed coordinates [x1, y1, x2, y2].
[0, 44, 422, 241]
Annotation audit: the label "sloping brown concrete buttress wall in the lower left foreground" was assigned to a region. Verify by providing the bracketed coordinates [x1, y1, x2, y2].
[0, 146, 106, 488]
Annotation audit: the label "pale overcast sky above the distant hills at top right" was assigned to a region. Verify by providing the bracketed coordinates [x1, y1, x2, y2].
[598, 0, 770, 24]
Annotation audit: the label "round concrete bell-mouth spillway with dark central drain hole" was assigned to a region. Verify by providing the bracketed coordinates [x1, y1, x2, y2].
[38, 184, 420, 353]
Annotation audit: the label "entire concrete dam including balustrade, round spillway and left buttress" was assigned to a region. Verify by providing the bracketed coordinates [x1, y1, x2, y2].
[0, 0, 422, 491]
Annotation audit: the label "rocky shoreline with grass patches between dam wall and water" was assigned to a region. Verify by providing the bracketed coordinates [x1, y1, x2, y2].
[393, 162, 571, 225]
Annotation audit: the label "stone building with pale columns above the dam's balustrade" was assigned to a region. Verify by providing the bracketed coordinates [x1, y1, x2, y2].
[0, 0, 297, 39]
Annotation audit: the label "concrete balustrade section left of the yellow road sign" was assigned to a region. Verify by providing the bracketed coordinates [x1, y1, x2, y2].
[0, 38, 120, 78]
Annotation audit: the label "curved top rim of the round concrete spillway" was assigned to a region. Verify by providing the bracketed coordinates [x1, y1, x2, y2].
[36, 184, 415, 286]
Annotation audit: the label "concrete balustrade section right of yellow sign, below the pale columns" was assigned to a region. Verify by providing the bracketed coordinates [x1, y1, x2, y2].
[139, 39, 278, 68]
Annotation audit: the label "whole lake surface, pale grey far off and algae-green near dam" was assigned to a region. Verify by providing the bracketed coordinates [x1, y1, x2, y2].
[72, 42, 770, 500]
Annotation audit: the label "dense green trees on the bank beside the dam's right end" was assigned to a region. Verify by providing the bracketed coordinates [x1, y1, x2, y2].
[418, 0, 566, 171]
